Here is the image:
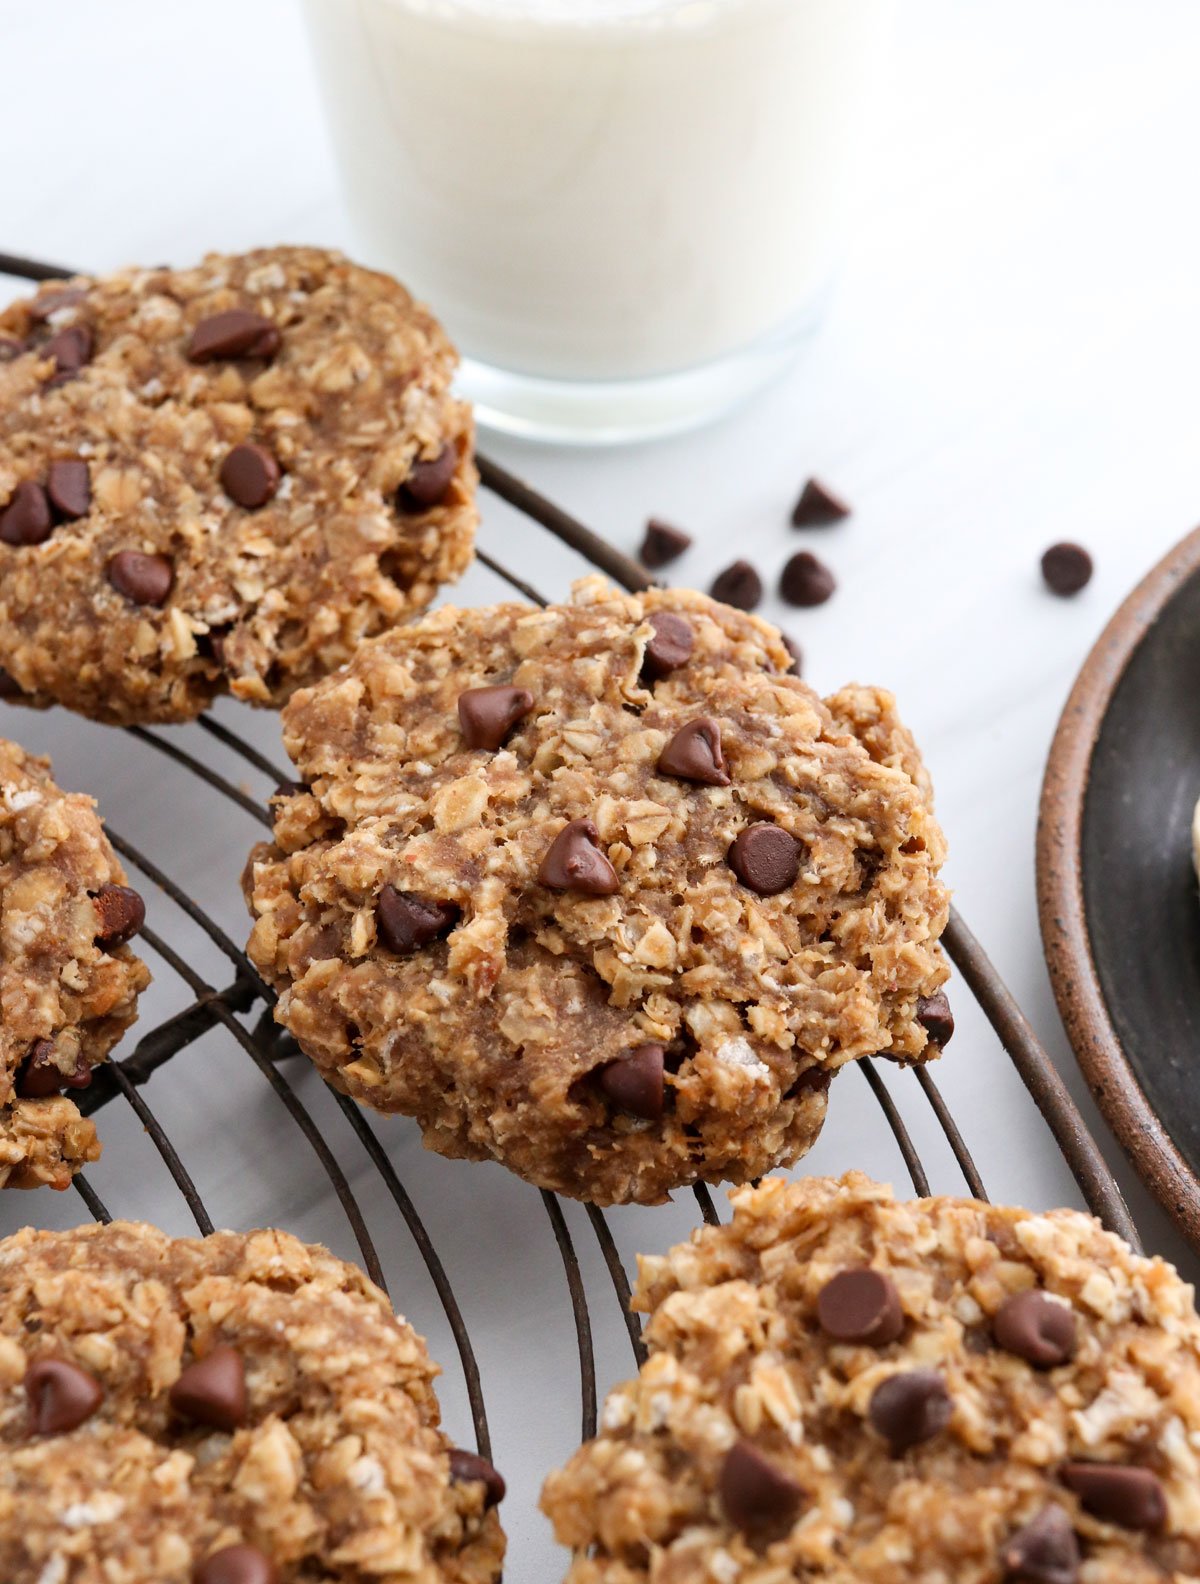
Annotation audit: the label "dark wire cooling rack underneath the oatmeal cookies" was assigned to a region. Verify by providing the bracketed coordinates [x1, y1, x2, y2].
[0, 253, 1138, 1482]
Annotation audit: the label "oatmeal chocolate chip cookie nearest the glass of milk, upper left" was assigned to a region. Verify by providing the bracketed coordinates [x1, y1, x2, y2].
[0, 247, 477, 722]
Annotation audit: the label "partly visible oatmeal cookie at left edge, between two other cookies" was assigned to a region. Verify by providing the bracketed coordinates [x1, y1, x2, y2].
[0, 738, 150, 1188]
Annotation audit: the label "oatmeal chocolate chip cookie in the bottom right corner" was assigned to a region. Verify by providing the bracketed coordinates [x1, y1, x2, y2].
[543, 1172, 1200, 1584]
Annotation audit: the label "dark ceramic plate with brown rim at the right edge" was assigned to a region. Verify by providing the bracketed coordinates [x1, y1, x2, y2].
[1037, 529, 1200, 1247]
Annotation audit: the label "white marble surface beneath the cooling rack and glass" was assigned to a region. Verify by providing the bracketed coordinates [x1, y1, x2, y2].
[0, 0, 1200, 1584]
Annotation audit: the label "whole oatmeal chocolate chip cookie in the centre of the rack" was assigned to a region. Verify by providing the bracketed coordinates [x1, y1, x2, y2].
[245, 578, 947, 1202]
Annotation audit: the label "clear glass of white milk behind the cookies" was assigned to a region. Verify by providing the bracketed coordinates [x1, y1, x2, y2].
[304, 0, 893, 440]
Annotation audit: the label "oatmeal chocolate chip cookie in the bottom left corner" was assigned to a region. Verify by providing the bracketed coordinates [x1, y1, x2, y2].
[0, 1221, 503, 1584]
